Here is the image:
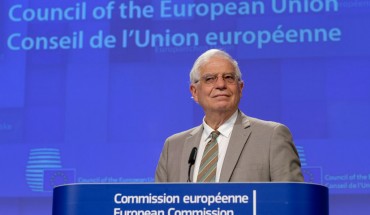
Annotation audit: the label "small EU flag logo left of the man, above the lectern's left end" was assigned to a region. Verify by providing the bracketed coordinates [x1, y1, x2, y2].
[44, 169, 76, 191]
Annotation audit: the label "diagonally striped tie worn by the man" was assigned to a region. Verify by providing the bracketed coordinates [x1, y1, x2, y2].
[197, 131, 220, 182]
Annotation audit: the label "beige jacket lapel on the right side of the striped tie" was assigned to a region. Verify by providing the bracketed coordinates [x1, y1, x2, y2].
[220, 111, 251, 182]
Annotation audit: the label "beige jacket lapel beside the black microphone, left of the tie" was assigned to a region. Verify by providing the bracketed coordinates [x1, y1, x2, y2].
[180, 125, 203, 182]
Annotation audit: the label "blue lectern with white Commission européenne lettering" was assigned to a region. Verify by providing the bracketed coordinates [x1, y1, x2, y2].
[53, 183, 329, 215]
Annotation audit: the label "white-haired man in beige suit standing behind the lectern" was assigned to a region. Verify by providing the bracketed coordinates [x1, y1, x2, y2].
[155, 49, 303, 182]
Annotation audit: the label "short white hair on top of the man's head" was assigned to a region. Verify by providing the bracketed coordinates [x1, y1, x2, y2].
[190, 49, 242, 84]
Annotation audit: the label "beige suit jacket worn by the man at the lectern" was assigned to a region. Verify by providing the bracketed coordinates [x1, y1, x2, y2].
[155, 111, 303, 182]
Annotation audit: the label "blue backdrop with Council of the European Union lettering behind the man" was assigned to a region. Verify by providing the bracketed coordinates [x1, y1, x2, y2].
[0, 0, 370, 215]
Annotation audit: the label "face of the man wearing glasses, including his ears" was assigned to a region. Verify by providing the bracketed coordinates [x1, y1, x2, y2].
[190, 57, 244, 114]
